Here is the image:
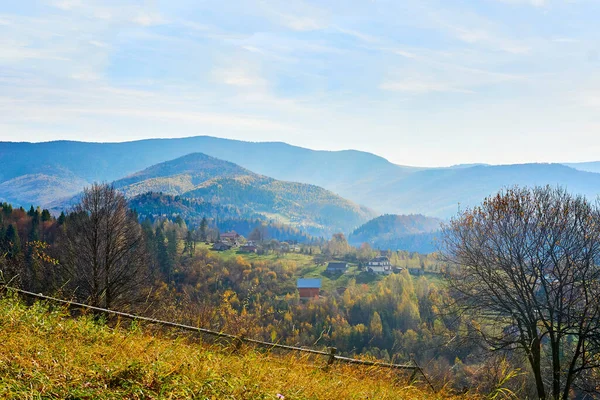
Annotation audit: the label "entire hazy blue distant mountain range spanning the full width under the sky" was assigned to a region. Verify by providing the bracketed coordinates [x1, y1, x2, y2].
[0, 136, 600, 218]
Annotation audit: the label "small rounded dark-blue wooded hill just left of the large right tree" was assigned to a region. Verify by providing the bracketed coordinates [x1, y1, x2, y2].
[348, 214, 442, 253]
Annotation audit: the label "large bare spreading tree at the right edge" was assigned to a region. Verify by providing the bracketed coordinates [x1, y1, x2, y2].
[442, 187, 600, 399]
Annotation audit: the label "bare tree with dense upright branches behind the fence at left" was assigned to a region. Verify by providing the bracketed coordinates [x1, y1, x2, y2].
[62, 184, 147, 308]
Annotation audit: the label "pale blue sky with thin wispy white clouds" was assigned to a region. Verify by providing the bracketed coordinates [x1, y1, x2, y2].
[0, 0, 600, 166]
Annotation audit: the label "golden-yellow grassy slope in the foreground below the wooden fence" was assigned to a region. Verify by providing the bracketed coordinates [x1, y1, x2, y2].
[0, 296, 472, 400]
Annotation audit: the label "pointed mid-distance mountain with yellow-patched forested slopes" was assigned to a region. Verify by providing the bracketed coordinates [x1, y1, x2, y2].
[114, 153, 375, 235]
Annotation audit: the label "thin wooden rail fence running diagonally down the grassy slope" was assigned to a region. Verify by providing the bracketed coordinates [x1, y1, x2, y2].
[0, 285, 435, 391]
